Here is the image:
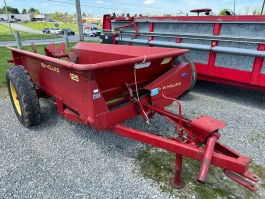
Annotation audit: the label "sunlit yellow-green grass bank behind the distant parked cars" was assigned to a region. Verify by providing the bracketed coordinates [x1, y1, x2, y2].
[22, 22, 78, 33]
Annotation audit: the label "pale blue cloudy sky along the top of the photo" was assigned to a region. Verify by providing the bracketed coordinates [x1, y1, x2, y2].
[0, 0, 263, 15]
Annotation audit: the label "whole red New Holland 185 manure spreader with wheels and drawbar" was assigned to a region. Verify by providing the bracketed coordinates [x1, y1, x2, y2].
[6, 42, 258, 191]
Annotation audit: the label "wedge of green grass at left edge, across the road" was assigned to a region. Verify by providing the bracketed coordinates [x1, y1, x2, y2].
[0, 24, 61, 41]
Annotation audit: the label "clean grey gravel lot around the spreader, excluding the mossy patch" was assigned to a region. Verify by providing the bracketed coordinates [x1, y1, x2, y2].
[0, 82, 265, 198]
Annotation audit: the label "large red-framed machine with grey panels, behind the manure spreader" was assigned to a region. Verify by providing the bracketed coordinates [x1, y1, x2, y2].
[101, 15, 265, 90]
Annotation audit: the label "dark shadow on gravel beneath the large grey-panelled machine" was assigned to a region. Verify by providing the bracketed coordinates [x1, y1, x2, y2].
[192, 81, 265, 109]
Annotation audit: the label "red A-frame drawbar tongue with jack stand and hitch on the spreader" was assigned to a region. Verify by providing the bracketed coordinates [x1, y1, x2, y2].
[114, 103, 258, 191]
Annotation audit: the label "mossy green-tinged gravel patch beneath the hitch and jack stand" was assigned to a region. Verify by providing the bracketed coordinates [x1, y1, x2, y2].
[136, 146, 265, 199]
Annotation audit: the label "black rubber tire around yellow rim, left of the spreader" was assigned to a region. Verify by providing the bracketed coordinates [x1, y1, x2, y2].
[6, 66, 40, 127]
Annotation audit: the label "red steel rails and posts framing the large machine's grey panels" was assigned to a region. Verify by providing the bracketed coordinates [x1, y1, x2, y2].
[103, 15, 265, 90]
